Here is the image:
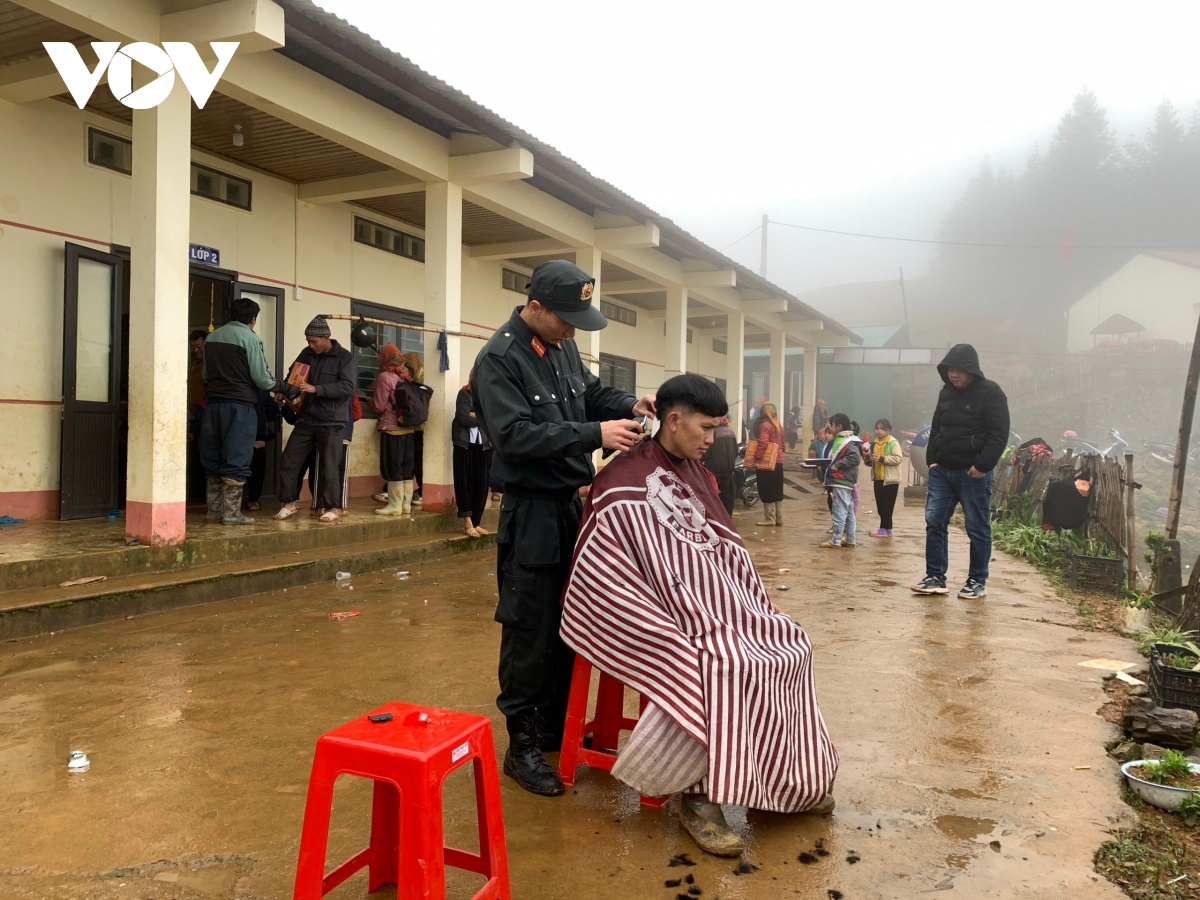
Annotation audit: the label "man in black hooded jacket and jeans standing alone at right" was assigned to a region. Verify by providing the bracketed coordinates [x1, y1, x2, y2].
[912, 343, 1008, 600]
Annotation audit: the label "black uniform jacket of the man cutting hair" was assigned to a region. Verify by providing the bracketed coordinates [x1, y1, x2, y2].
[474, 306, 636, 499]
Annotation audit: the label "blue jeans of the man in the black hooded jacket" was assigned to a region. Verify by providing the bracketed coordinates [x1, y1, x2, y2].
[925, 466, 995, 584]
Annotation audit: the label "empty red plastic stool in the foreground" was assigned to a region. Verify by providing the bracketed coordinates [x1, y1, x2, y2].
[293, 703, 511, 900]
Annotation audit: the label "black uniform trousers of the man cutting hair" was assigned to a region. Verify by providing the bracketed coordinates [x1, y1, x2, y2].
[496, 494, 583, 733]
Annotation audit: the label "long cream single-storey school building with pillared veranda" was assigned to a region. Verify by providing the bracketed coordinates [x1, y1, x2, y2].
[0, 0, 858, 545]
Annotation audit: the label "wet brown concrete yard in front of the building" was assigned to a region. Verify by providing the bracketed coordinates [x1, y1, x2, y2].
[0, 496, 1135, 900]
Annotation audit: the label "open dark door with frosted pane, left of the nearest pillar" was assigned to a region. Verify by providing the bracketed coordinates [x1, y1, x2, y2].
[59, 244, 124, 518]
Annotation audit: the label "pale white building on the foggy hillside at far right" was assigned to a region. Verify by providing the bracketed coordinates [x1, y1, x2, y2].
[1067, 252, 1200, 353]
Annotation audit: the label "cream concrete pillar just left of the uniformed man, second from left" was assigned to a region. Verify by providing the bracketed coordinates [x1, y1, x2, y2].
[421, 181, 467, 512]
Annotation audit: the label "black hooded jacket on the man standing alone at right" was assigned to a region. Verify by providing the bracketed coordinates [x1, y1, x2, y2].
[925, 343, 1009, 472]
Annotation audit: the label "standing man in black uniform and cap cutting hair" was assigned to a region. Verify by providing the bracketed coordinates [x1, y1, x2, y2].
[474, 259, 654, 797]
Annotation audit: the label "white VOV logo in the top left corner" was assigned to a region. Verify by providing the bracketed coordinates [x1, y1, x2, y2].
[42, 41, 239, 109]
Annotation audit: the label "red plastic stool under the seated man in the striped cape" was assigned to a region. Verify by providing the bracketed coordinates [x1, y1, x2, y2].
[558, 654, 670, 809]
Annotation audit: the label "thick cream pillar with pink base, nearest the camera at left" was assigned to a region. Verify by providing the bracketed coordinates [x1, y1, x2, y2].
[125, 78, 192, 546]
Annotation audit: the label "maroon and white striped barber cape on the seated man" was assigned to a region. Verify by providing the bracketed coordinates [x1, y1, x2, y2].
[562, 440, 838, 812]
